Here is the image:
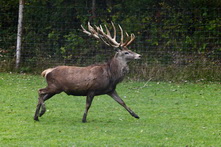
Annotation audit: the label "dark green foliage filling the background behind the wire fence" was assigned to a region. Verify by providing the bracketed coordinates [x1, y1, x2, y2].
[0, 0, 221, 80]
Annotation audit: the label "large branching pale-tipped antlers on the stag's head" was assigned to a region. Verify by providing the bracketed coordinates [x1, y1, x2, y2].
[81, 22, 135, 48]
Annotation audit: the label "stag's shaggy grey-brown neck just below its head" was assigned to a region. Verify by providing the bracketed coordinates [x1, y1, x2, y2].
[109, 57, 129, 83]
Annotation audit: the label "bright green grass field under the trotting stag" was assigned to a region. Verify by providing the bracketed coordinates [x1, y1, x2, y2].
[0, 73, 221, 147]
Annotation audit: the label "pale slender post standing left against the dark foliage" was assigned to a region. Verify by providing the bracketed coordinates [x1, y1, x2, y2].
[15, 0, 25, 69]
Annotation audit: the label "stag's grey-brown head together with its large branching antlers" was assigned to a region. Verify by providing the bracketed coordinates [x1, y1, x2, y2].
[81, 22, 141, 62]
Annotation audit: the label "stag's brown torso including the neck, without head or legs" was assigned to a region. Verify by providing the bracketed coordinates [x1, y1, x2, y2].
[40, 54, 129, 96]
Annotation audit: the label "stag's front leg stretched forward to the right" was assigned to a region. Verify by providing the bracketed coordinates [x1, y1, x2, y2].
[108, 91, 140, 119]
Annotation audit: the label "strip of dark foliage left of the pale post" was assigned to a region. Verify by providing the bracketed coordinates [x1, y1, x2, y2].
[0, 0, 18, 61]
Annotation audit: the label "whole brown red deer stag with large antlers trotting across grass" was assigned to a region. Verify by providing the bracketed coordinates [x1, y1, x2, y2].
[34, 22, 141, 122]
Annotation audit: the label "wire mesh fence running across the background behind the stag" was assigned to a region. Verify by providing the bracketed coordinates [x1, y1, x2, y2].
[0, 3, 221, 80]
